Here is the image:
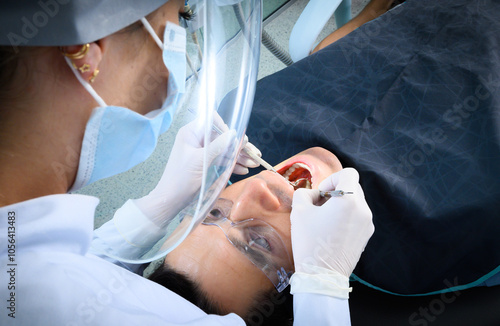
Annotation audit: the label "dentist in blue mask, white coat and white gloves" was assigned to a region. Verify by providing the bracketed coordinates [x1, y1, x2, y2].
[0, 0, 373, 325]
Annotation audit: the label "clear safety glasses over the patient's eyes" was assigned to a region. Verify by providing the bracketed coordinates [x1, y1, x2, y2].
[202, 198, 293, 292]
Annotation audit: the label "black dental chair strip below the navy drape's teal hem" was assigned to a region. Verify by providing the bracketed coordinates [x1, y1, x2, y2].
[349, 283, 500, 326]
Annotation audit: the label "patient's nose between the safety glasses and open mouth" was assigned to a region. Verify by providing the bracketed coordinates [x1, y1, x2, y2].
[231, 179, 281, 221]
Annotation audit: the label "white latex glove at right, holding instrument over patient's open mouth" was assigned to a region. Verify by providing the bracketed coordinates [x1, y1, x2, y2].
[290, 168, 374, 298]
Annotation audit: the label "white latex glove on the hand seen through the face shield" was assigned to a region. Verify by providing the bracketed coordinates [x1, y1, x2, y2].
[132, 116, 236, 226]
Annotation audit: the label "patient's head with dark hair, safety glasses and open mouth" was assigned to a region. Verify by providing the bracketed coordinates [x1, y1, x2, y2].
[150, 147, 342, 325]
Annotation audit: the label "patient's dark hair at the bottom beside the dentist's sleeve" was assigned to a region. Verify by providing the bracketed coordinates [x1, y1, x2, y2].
[149, 264, 293, 326]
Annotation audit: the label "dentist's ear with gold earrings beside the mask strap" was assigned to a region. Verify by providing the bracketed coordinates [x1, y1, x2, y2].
[60, 41, 103, 82]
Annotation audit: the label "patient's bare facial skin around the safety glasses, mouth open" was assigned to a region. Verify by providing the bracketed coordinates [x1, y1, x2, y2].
[165, 147, 342, 315]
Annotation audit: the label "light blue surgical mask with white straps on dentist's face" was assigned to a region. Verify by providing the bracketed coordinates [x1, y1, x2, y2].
[67, 19, 186, 191]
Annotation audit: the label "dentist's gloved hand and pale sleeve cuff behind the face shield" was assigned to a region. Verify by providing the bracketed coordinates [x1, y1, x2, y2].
[108, 113, 260, 257]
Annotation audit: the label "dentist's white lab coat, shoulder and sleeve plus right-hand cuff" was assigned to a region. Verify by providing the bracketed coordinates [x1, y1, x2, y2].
[0, 194, 350, 326]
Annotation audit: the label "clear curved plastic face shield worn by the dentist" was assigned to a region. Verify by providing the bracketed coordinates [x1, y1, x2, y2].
[87, 0, 262, 263]
